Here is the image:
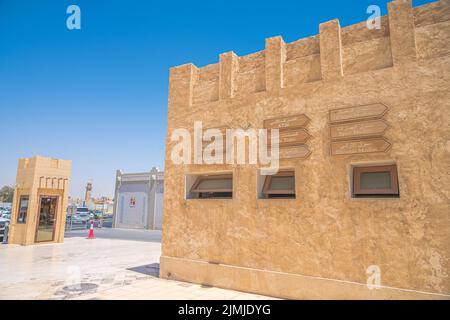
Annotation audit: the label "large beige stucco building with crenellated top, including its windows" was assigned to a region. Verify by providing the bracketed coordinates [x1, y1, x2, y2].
[160, 0, 450, 299]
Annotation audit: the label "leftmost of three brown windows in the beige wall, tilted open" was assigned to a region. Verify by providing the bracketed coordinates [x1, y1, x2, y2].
[191, 174, 233, 199]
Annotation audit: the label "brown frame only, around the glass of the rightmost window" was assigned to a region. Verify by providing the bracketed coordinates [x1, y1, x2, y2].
[352, 164, 400, 197]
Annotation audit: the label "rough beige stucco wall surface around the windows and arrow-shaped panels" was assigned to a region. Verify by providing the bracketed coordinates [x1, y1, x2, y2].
[161, 1, 450, 298]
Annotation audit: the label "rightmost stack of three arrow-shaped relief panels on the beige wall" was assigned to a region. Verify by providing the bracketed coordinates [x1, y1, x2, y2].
[329, 103, 391, 156]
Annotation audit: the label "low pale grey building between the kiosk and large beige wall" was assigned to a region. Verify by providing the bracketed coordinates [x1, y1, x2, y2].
[113, 168, 164, 230]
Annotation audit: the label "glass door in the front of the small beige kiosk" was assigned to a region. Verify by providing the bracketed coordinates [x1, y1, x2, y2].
[36, 196, 58, 242]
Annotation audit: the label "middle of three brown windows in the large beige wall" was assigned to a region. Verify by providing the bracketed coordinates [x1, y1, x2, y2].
[263, 171, 295, 199]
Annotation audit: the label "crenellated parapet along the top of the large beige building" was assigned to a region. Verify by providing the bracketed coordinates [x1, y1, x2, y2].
[169, 0, 450, 108]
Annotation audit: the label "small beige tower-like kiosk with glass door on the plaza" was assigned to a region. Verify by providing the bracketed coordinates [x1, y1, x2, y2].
[8, 156, 71, 245]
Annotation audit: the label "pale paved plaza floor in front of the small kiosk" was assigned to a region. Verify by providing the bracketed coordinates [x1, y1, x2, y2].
[0, 229, 274, 300]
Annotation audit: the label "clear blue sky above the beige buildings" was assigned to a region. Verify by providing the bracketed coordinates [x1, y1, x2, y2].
[0, 0, 432, 196]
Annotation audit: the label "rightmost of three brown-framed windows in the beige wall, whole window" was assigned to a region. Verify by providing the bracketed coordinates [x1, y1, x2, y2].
[353, 165, 400, 197]
